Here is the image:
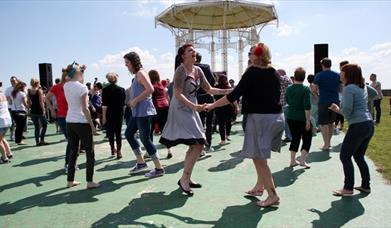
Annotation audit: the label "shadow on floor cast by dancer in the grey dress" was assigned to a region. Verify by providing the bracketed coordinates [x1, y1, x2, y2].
[91, 189, 214, 227]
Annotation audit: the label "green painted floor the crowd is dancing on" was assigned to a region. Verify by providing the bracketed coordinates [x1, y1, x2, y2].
[0, 120, 391, 227]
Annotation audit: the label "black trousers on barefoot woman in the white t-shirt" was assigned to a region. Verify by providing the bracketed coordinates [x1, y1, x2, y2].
[67, 122, 95, 182]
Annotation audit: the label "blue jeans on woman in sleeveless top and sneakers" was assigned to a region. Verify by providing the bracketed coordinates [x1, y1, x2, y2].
[125, 116, 158, 160]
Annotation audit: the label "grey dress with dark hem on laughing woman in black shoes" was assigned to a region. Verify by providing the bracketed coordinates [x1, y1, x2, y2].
[159, 64, 208, 147]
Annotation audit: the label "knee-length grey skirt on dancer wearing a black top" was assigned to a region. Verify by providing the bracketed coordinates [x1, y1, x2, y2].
[241, 113, 285, 159]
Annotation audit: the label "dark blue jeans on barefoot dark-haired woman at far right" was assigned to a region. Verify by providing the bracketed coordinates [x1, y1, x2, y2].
[339, 121, 374, 190]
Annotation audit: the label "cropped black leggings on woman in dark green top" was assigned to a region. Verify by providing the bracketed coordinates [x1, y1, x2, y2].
[288, 119, 312, 152]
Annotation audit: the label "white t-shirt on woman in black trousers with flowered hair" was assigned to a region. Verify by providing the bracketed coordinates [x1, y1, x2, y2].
[64, 81, 88, 123]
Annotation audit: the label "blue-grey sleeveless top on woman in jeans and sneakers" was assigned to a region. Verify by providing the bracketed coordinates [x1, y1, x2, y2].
[130, 74, 156, 117]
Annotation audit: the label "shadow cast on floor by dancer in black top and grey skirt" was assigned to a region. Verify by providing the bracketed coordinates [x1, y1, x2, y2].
[214, 196, 278, 228]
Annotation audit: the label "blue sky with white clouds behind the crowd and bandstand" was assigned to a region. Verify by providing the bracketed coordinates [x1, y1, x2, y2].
[0, 0, 391, 89]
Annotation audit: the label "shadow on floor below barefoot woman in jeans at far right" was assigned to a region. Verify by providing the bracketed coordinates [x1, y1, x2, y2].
[309, 193, 368, 227]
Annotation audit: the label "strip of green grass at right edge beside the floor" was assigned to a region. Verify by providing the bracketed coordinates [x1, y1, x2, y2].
[367, 97, 391, 181]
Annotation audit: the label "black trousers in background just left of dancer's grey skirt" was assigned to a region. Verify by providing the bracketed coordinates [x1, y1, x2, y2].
[216, 105, 233, 141]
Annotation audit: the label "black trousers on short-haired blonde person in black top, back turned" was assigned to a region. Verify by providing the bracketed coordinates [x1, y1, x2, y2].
[106, 113, 124, 151]
